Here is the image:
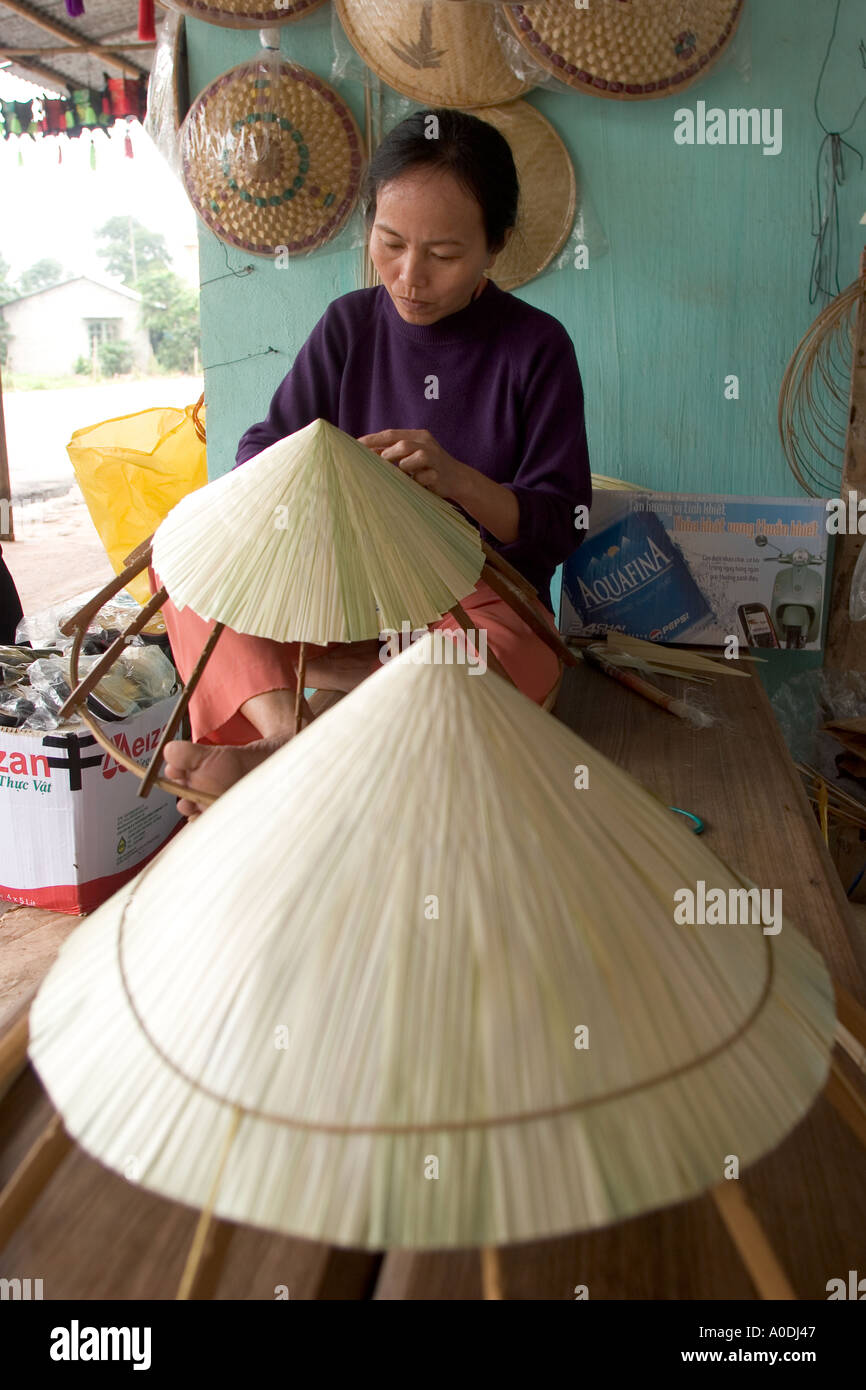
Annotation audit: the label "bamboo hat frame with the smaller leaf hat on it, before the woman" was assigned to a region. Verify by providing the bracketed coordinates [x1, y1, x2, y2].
[50, 420, 577, 805]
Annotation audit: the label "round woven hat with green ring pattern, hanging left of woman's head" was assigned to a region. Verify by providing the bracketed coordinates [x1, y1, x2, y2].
[181, 58, 364, 256]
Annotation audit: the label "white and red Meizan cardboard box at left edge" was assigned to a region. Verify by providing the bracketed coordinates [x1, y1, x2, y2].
[0, 699, 182, 915]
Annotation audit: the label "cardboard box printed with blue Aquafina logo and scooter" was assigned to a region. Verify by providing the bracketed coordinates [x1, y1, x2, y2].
[560, 489, 828, 651]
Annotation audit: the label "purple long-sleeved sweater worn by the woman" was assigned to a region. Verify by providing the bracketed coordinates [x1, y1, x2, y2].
[236, 281, 592, 607]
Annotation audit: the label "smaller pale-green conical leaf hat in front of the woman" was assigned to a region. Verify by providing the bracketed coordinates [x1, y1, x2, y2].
[153, 420, 484, 644]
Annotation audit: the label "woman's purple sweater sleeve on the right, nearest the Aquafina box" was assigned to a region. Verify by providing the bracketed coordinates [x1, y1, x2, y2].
[500, 325, 592, 571]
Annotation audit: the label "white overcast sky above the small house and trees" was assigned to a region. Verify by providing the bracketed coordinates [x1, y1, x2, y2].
[0, 71, 197, 284]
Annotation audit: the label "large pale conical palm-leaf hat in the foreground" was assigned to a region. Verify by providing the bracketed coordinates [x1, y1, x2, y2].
[31, 634, 834, 1248]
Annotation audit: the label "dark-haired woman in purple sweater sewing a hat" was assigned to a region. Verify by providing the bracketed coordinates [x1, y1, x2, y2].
[165, 110, 591, 815]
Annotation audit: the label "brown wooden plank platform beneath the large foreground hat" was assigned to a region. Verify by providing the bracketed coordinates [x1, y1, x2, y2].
[0, 666, 866, 1300]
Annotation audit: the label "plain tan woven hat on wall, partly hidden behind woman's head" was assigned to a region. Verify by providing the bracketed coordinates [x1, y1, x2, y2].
[474, 101, 577, 289]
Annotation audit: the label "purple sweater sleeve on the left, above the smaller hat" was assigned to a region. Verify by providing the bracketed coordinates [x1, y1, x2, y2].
[235, 306, 348, 467]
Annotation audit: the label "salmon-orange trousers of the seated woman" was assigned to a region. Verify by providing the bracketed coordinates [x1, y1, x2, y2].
[149, 569, 559, 746]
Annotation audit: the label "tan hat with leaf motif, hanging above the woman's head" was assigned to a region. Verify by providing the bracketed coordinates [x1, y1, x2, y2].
[335, 0, 531, 107]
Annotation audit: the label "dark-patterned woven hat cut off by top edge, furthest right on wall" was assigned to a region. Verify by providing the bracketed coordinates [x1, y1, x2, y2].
[502, 0, 744, 101]
